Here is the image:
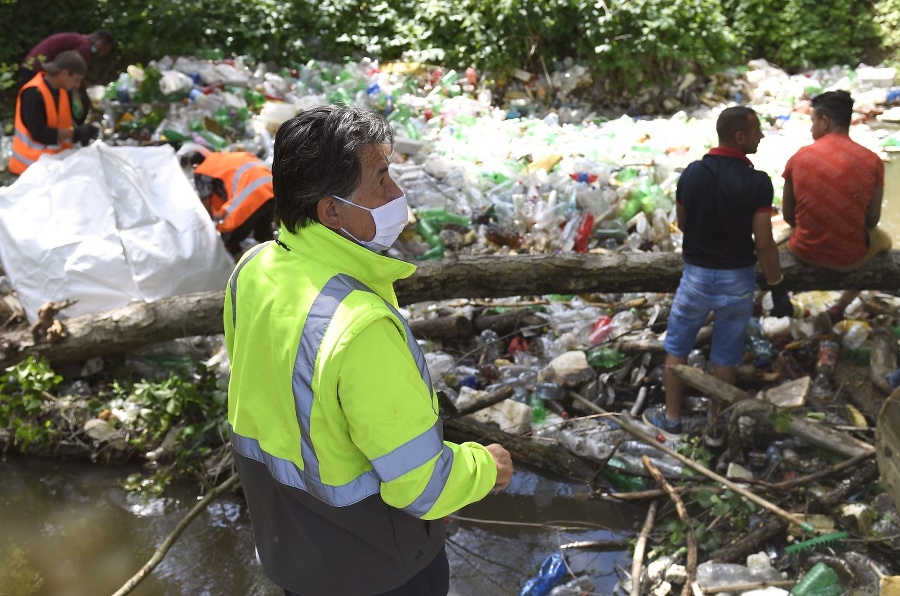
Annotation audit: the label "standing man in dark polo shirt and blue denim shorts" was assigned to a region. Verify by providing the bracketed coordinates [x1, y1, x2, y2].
[644, 106, 792, 446]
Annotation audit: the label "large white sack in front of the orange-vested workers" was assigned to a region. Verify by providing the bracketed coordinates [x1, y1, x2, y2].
[0, 142, 234, 321]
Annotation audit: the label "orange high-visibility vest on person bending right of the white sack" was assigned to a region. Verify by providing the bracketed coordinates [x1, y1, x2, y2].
[194, 151, 275, 233]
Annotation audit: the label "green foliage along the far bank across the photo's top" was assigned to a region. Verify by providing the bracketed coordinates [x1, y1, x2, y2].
[0, 0, 900, 116]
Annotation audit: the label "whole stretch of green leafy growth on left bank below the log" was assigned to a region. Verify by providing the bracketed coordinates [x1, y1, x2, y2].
[0, 357, 228, 494]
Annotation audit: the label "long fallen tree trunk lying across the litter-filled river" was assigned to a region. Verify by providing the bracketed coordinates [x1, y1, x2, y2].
[0, 251, 900, 368]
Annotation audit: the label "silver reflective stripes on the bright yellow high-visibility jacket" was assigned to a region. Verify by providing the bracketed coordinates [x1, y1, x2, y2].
[230, 260, 453, 517]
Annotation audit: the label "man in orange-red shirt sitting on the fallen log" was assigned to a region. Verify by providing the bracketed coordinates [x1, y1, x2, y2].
[782, 91, 891, 322]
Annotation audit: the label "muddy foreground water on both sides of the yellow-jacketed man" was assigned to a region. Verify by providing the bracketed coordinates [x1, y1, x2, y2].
[0, 458, 643, 596]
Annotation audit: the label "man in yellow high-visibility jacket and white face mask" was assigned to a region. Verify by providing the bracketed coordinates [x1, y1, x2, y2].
[224, 105, 512, 596]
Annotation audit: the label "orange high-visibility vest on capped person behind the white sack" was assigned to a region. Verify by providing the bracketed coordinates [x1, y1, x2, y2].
[9, 73, 75, 176]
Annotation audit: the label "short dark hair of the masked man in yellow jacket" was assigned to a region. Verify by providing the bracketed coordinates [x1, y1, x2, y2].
[272, 104, 394, 232]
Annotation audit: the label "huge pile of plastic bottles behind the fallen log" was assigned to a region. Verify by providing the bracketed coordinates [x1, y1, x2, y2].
[7, 55, 888, 260]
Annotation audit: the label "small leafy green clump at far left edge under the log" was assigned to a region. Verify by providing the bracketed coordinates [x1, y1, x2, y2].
[0, 356, 62, 451]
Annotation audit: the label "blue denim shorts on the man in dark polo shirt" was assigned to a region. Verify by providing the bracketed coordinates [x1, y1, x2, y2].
[664, 263, 756, 366]
